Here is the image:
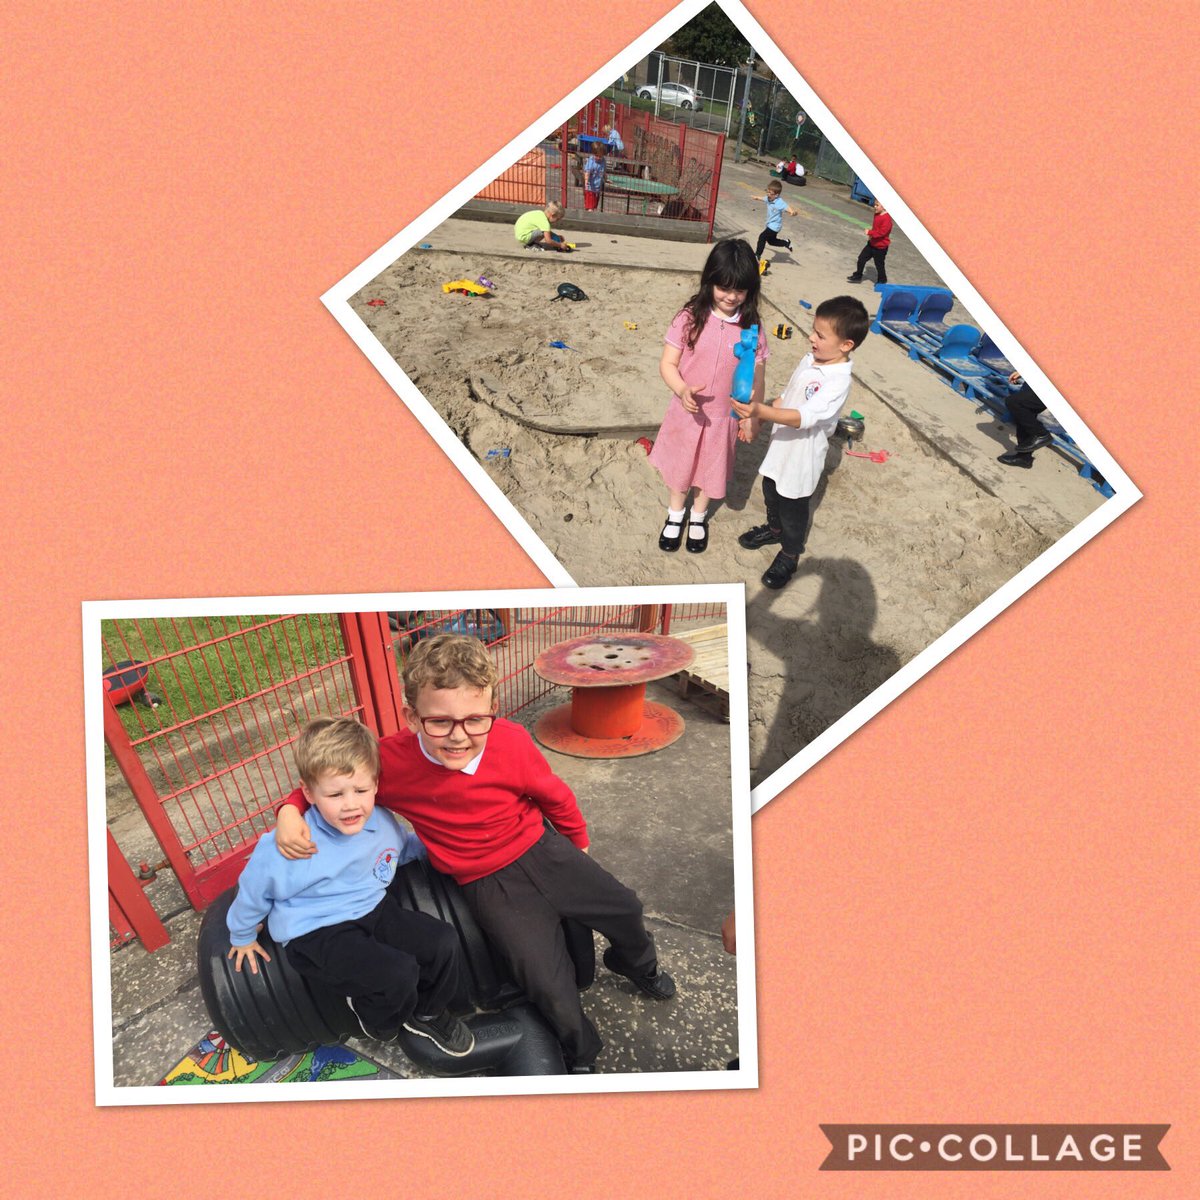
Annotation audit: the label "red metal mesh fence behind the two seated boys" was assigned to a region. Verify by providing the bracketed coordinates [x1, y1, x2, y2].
[101, 605, 725, 949]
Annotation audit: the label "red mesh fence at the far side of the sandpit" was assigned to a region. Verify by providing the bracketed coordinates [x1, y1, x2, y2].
[476, 100, 725, 241]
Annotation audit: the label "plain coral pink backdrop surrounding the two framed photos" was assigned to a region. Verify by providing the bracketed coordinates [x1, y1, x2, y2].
[0, 0, 1200, 1200]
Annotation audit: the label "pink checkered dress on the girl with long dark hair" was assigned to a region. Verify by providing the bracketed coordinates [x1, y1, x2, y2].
[650, 310, 769, 500]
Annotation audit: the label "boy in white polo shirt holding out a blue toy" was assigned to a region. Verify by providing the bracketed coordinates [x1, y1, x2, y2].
[733, 296, 871, 588]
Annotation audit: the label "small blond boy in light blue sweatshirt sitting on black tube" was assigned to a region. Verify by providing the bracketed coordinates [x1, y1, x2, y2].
[226, 718, 475, 1057]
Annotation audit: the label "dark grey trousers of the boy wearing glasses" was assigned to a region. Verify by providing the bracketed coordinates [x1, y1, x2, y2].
[462, 829, 658, 1066]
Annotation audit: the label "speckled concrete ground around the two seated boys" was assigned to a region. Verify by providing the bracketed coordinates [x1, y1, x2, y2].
[109, 684, 752, 1087]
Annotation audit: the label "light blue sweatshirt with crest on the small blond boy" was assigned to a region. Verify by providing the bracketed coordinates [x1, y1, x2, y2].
[226, 808, 425, 946]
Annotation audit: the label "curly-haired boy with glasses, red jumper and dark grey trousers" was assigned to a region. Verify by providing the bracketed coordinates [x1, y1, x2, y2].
[276, 634, 676, 1073]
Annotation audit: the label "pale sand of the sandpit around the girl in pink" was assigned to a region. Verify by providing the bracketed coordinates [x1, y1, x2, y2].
[353, 174, 1102, 785]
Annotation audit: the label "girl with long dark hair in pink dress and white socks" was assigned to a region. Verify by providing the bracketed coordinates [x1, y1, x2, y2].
[650, 238, 767, 554]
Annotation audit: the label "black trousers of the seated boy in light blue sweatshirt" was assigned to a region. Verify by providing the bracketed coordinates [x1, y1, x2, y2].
[284, 894, 462, 1032]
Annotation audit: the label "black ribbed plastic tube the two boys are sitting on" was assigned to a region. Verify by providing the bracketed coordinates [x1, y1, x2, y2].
[197, 859, 595, 1075]
